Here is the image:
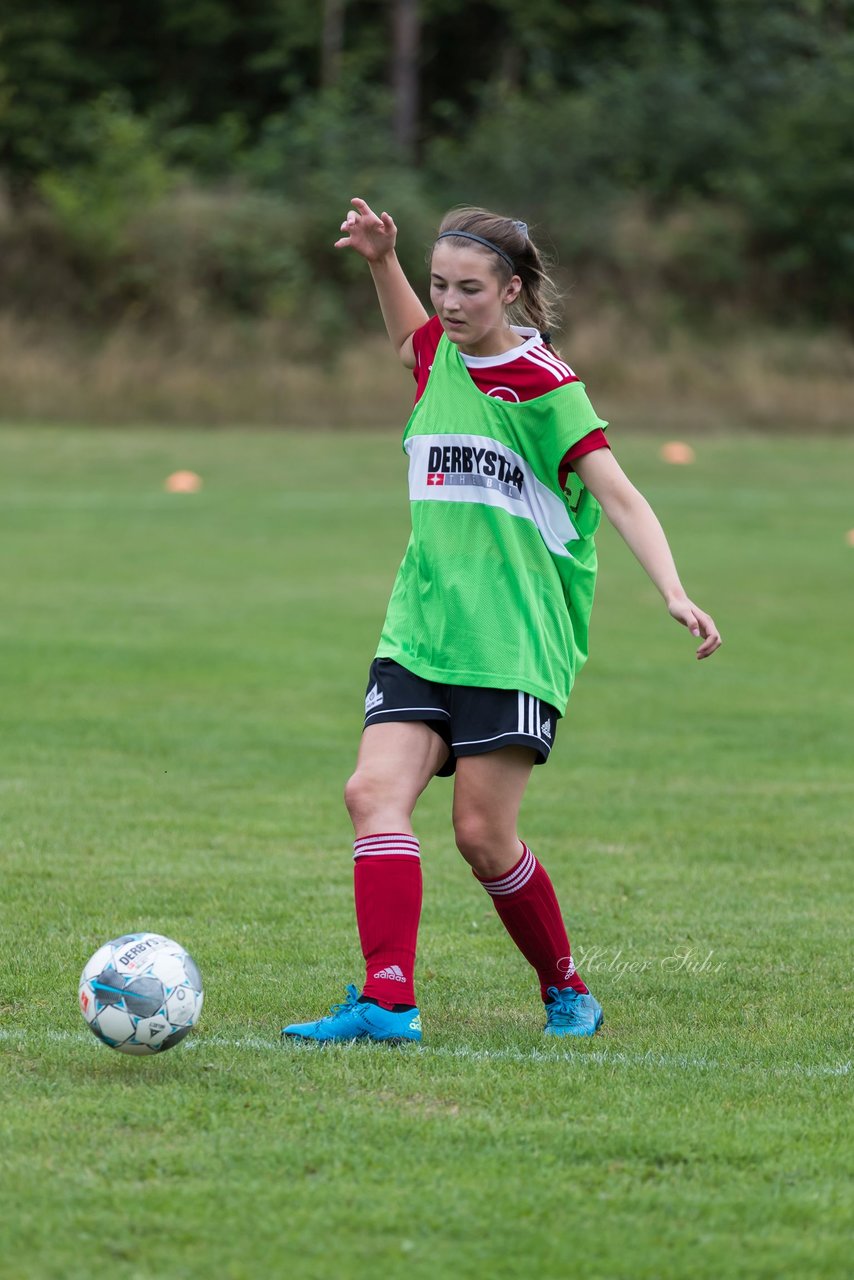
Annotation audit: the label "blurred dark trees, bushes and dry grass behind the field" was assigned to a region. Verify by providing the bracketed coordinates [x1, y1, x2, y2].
[0, 0, 854, 428]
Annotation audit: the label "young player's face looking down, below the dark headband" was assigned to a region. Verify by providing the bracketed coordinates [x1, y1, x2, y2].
[430, 241, 521, 356]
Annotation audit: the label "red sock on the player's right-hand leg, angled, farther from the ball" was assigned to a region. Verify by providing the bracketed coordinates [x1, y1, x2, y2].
[476, 845, 588, 1000]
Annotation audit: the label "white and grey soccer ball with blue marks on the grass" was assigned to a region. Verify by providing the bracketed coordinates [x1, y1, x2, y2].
[78, 933, 205, 1053]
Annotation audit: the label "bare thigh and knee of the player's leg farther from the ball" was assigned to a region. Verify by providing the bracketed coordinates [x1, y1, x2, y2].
[453, 746, 535, 879]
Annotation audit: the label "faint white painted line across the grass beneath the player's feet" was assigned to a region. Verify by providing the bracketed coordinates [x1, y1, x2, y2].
[0, 1028, 851, 1076]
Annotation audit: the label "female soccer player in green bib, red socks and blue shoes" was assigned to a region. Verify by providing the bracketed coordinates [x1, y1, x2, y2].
[282, 200, 721, 1042]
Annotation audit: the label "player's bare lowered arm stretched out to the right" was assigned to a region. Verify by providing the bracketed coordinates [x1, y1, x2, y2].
[572, 449, 721, 658]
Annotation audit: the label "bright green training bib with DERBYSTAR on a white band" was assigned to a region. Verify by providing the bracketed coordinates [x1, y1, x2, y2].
[376, 334, 607, 714]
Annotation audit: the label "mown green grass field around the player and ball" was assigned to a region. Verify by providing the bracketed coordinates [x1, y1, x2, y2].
[0, 428, 854, 1280]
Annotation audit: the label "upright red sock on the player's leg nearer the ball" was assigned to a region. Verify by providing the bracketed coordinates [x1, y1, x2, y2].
[353, 833, 421, 1009]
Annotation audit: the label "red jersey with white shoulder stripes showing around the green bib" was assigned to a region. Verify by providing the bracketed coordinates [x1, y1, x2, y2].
[412, 316, 611, 484]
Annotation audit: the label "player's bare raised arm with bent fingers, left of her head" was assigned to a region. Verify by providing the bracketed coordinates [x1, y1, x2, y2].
[335, 197, 429, 369]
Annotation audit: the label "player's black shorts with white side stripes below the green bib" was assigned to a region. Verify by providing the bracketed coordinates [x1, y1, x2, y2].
[365, 658, 560, 777]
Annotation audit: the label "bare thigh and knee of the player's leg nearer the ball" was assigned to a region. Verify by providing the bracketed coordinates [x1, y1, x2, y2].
[344, 721, 448, 840]
